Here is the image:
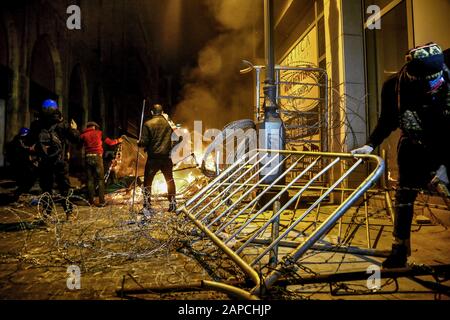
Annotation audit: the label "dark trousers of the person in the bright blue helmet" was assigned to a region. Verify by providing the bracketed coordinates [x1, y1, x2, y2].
[39, 160, 72, 213]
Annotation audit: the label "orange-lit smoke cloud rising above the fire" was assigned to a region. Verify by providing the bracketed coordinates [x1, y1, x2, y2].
[174, 0, 263, 129]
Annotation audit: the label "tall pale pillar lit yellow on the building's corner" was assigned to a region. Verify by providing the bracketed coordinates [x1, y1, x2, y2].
[324, 0, 367, 152]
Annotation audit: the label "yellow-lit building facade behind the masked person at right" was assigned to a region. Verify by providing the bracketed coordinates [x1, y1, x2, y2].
[275, 0, 450, 179]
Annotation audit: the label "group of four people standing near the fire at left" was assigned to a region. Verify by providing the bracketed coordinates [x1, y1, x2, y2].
[6, 99, 176, 219]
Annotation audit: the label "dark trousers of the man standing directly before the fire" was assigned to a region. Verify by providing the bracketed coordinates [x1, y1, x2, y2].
[144, 158, 176, 207]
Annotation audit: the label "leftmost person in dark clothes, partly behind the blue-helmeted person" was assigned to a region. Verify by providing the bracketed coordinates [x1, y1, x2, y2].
[6, 128, 37, 201]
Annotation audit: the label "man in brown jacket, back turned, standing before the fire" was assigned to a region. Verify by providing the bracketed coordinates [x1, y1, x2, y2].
[138, 104, 176, 213]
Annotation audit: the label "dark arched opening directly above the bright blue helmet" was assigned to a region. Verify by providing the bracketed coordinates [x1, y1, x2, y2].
[28, 35, 63, 112]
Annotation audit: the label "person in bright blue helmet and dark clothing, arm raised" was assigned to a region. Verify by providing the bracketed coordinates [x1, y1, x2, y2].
[31, 99, 80, 218]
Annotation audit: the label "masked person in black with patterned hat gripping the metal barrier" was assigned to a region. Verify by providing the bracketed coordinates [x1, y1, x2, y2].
[352, 43, 450, 268]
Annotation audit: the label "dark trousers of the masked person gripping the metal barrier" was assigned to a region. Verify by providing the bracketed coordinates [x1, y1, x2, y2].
[393, 138, 444, 240]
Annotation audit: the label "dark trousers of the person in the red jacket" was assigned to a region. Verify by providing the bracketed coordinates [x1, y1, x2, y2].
[86, 155, 105, 204]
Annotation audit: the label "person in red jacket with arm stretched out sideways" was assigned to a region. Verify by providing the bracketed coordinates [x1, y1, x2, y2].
[80, 121, 122, 207]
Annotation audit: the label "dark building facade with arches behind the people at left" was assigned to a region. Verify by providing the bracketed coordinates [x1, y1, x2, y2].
[0, 0, 160, 167]
